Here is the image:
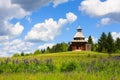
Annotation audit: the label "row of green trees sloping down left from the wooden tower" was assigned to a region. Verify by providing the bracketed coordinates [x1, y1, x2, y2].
[13, 42, 69, 57]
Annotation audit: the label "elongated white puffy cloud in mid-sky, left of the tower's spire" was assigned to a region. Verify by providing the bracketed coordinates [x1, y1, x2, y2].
[25, 12, 77, 42]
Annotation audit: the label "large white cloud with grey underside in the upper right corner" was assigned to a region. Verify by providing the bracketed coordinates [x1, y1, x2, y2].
[79, 0, 120, 23]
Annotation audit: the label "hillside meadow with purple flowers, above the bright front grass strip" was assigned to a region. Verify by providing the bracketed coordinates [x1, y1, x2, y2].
[0, 52, 120, 74]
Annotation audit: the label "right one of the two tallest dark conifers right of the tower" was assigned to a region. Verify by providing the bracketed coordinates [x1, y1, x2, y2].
[107, 32, 115, 54]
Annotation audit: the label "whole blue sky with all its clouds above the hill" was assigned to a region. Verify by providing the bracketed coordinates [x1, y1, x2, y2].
[0, 0, 120, 57]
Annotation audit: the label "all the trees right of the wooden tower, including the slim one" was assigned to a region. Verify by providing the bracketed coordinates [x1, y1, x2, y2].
[88, 32, 120, 54]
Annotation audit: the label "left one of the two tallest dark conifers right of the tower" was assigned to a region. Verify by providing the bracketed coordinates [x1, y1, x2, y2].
[98, 32, 107, 52]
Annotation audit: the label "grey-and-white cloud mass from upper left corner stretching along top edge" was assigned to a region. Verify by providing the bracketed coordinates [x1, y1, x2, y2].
[0, 0, 68, 36]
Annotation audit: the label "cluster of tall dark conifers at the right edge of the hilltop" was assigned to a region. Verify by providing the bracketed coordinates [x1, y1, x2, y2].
[98, 32, 120, 54]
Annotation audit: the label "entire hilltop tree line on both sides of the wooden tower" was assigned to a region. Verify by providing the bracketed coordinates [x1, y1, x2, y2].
[13, 32, 120, 56]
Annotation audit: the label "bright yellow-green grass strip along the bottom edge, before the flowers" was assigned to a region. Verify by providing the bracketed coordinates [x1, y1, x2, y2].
[0, 72, 120, 80]
